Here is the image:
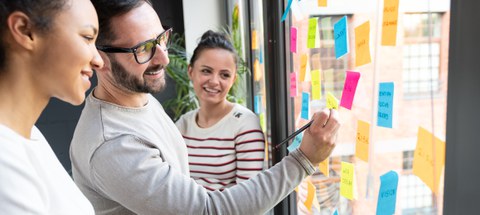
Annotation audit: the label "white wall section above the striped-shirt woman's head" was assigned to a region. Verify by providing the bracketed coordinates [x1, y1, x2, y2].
[183, 0, 227, 59]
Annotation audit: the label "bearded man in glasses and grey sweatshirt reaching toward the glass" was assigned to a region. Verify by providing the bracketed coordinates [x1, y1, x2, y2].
[70, 0, 340, 214]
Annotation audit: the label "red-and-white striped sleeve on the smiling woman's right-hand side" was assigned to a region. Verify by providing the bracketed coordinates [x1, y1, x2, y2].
[234, 115, 265, 184]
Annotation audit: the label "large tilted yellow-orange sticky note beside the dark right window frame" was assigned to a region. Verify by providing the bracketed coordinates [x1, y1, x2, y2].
[413, 127, 445, 193]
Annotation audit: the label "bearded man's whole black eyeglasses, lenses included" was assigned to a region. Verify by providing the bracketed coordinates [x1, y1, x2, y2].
[97, 28, 173, 64]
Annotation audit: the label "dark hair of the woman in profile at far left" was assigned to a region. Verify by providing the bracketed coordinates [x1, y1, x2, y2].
[0, 0, 68, 68]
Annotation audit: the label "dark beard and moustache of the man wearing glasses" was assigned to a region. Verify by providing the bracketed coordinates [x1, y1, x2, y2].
[110, 58, 166, 93]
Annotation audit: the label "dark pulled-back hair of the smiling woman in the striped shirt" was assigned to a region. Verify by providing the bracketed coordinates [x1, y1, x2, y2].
[190, 30, 238, 65]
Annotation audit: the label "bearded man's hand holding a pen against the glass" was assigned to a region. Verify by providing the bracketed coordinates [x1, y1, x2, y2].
[300, 109, 340, 165]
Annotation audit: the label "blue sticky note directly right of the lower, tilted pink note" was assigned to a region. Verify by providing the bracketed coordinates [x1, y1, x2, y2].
[377, 82, 394, 128]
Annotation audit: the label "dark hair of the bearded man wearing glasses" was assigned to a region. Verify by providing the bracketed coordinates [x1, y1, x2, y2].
[92, 0, 152, 45]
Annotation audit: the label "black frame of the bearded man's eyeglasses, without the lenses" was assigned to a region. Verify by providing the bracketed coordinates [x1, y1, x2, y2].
[96, 28, 173, 64]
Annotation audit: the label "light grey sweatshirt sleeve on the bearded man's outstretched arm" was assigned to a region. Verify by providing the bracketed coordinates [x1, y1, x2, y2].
[90, 135, 315, 214]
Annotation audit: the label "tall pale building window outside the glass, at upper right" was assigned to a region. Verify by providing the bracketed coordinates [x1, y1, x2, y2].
[403, 13, 442, 98]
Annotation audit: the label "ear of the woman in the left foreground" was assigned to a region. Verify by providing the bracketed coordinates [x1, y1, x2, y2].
[7, 11, 35, 50]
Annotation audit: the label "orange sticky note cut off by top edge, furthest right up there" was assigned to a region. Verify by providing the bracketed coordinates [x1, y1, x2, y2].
[382, 0, 398, 46]
